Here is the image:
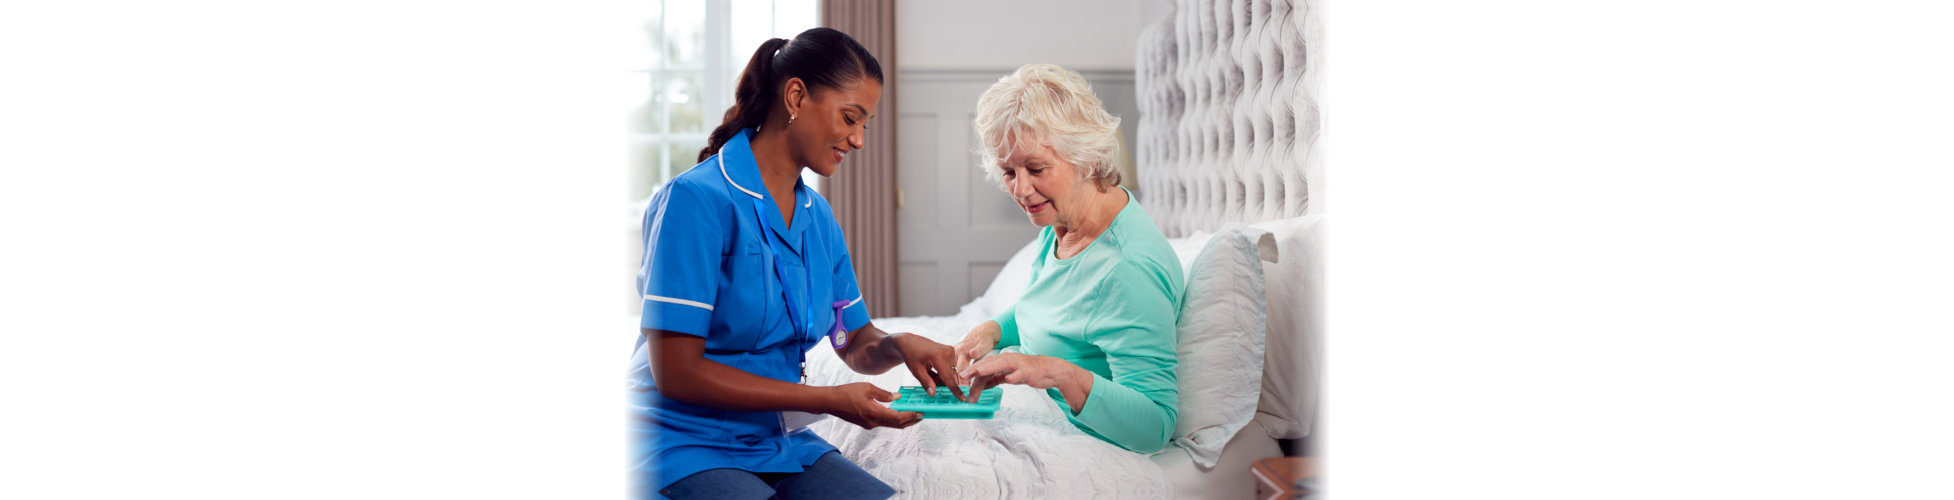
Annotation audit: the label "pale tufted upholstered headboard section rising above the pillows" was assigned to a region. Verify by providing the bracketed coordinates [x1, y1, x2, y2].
[1135, 0, 1323, 238]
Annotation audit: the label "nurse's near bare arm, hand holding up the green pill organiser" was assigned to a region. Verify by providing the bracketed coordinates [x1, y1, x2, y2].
[643, 328, 920, 428]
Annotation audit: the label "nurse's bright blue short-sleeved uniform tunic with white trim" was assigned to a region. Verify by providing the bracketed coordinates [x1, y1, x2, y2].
[625, 129, 868, 496]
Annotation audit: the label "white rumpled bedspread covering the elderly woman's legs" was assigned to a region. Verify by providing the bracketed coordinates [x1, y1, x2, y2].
[807, 307, 1172, 498]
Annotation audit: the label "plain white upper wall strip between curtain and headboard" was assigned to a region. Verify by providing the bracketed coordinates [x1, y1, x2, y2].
[895, 0, 1167, 70]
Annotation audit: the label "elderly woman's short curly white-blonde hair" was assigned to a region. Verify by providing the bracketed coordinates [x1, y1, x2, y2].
[973, 64, 1120, 188]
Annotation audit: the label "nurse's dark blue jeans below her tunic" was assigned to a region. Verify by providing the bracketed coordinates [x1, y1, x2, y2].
[658, 451, 895, 500]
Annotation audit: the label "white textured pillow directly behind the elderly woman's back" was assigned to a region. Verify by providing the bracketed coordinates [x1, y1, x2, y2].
[1174, 225, 1274, 467]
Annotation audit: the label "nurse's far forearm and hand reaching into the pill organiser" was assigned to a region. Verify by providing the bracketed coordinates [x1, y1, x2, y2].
[838, 322, 965, 398]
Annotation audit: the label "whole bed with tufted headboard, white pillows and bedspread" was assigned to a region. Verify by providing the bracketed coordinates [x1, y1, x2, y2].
[807, 0, 1325, 498]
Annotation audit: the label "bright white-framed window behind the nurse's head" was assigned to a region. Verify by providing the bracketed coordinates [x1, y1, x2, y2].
[627, 0, 821, 201]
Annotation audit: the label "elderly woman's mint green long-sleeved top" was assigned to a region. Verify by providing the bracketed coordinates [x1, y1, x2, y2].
[995, 193, 1186, 453]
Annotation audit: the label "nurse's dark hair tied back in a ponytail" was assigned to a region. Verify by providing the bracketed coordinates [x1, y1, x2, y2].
[700, 27, 881, 162]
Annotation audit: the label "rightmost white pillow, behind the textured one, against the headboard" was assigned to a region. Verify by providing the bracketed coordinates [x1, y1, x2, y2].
[1253, 215, 1323, 439]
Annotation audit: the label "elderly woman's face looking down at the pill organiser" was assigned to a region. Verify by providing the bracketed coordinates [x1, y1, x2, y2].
[998, 146, 1092, 229]
